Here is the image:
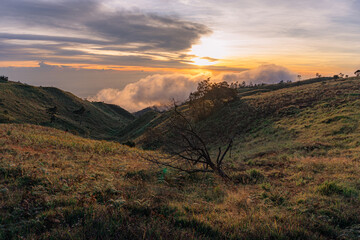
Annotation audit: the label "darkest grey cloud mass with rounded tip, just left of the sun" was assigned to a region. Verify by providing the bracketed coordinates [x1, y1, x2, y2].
[85, 11, 211, 51]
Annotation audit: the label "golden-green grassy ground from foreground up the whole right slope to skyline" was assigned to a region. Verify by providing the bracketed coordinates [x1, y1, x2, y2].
[0, 78, 360, 239]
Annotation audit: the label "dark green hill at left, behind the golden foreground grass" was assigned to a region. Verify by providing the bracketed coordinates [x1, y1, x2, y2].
[0, 81, 134, 139]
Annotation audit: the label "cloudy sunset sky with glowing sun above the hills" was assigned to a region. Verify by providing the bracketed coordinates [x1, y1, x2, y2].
[0, 0, 360, 111]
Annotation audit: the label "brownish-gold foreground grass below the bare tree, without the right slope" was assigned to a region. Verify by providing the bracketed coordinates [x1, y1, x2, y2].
[0, 124, 360, 239]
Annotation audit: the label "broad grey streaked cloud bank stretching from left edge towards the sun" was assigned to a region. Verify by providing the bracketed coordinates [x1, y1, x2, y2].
[0, 0, 212, 67]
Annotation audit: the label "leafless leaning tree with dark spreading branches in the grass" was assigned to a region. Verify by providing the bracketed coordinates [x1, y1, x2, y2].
[142, 105, 234, 180]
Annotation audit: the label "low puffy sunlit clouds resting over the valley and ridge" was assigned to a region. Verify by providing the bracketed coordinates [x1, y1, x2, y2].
[89, 65, 296, 112]
